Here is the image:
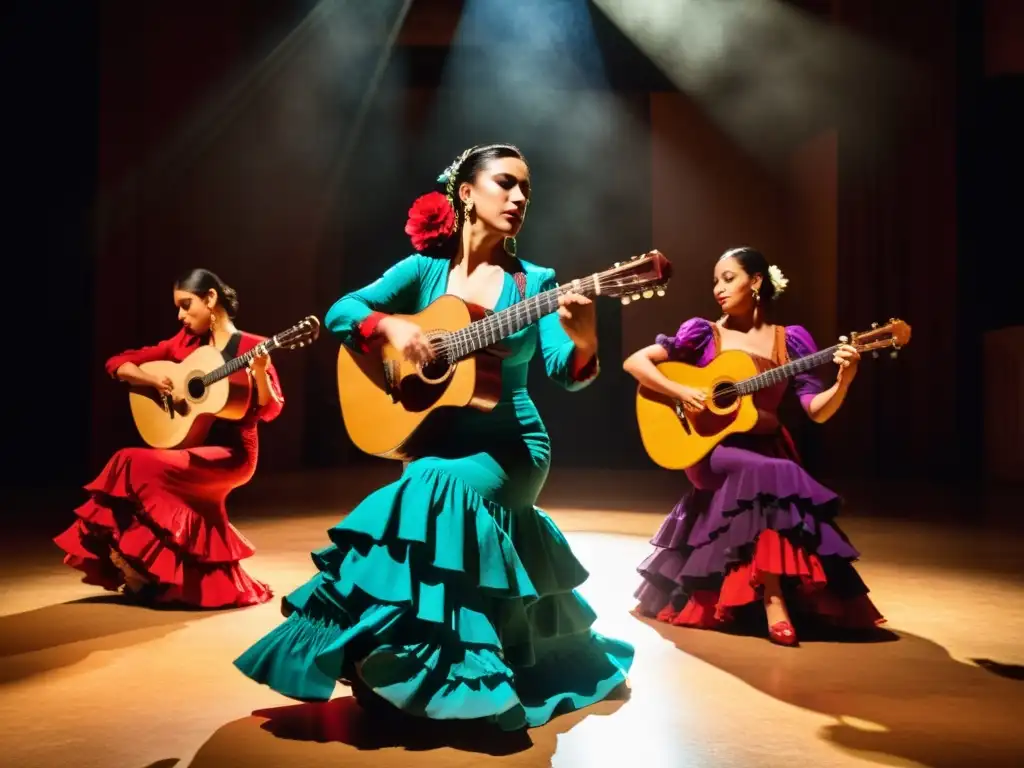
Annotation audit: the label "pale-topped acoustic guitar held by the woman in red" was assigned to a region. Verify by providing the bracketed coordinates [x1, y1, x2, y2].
[128, 315, 319, 449]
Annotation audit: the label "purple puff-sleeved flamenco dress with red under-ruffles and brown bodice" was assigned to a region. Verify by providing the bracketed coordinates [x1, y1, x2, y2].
[636, 317, 885, 629]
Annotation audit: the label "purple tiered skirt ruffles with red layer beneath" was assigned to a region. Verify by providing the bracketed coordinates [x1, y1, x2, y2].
[635, 447, 885, 628]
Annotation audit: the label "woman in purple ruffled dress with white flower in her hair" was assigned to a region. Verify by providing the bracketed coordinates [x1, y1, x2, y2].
[624, 248, 885, 646]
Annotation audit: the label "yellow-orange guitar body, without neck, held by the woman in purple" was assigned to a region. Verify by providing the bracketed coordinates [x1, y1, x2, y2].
[637, 350, 758, 469]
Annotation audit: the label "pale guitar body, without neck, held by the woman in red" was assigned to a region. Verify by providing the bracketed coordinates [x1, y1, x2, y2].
[128, 345, 252, 449]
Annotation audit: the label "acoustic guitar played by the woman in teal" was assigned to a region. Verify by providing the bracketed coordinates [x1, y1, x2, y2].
[338, 251, 672, 461]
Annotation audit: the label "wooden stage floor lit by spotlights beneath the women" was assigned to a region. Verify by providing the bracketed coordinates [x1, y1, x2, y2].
[0, 472, 1024, 768]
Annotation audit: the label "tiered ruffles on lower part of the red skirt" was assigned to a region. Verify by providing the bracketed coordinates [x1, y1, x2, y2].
[53, 456, 272, 608]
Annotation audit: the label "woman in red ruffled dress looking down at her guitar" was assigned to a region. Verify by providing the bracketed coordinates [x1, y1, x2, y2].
[54, 269, 285, 608]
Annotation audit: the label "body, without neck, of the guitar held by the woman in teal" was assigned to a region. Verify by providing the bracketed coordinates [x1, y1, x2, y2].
[338, 295, 502, 461]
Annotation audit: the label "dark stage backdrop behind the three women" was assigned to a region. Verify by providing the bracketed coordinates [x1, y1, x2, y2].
[0, 0, 1024, 512]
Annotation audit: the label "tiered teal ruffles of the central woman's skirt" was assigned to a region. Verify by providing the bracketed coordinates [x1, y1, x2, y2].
[236, 464, 633, 730]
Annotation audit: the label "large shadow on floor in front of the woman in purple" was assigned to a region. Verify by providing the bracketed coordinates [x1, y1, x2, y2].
[639, 618, 1024, 768]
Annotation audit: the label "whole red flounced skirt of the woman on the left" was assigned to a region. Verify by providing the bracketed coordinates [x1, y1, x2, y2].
[54, 446, 272, 608]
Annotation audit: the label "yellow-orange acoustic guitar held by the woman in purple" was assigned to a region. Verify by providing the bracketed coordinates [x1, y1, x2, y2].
[636, 319, 910, 469]
